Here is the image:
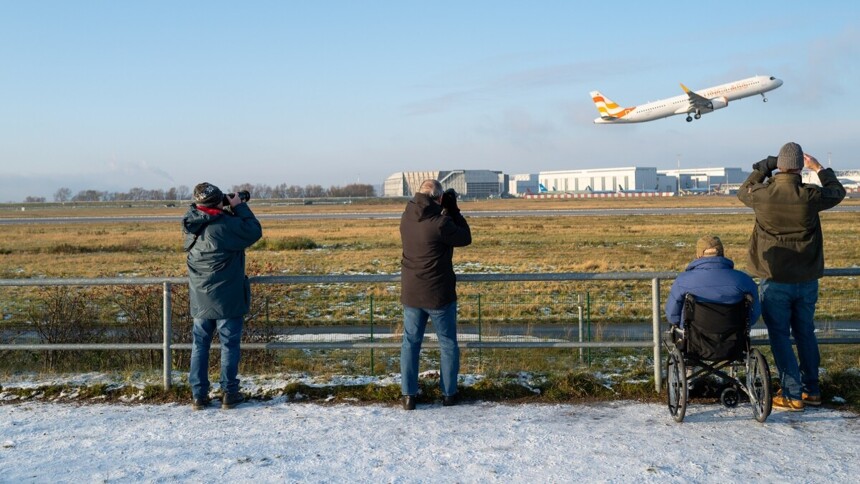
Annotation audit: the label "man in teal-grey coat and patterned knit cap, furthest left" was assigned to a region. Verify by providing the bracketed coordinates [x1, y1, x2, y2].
[182, 183, 263, 410]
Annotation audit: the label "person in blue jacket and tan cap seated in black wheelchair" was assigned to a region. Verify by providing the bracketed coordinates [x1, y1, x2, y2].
[666, 235, 770, 422]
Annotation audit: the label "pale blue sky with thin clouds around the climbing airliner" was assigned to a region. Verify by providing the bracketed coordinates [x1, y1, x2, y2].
[0, 0, 860, 201]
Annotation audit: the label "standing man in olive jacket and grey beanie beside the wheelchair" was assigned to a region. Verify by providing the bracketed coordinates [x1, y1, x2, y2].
[738, 143, 845, 411]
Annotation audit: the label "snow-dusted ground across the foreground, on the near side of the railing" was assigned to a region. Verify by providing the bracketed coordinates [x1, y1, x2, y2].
[0, 399, 860, 483]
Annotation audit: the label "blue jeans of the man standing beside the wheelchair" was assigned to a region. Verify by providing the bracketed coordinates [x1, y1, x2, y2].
[759, 279, 821, 400]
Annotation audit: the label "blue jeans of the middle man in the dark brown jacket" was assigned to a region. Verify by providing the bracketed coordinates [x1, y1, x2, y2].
[400, 301, 460, 397]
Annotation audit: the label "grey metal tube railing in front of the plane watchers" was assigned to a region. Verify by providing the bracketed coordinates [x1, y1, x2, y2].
[0, 268, 860, 391]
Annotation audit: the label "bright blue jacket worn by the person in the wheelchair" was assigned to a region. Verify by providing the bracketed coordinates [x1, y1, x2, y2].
[666, 256, 761, 326]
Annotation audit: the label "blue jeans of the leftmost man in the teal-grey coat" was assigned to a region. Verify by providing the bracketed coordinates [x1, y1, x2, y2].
[188, 318, 242, 399]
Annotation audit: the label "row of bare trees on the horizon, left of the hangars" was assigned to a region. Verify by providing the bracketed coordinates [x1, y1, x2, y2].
[37, 183, 376, 202]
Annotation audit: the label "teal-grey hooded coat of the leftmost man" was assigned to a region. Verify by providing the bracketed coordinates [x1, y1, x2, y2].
[182, 203, 263, 319]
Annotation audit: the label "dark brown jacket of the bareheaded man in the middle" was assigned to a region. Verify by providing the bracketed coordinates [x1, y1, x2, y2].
[400, 193, 472, 309]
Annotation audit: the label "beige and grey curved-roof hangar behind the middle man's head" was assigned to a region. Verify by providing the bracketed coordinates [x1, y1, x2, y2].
[382, 170, 507, 198]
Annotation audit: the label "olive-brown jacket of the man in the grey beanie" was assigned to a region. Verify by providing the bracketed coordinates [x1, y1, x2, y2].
[738, 168, 845, 283]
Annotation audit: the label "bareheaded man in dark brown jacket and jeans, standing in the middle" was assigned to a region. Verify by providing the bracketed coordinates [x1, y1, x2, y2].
[400, 180, 472, 410]
